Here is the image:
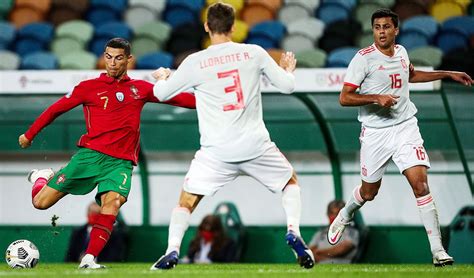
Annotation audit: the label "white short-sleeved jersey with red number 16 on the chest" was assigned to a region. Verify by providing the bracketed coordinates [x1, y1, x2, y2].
[344, 44, 417, 128]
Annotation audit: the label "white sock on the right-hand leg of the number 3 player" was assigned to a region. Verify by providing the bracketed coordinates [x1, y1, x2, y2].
[281, 184, 301, 236]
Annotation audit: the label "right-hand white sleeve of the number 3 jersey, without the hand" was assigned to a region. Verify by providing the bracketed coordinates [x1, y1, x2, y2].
[255, 45, 295, 94]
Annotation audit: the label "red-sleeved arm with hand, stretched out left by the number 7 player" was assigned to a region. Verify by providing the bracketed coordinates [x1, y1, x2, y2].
[18, 86, 82, 148]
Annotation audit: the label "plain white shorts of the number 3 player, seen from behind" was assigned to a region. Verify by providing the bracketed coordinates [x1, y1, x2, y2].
[183, 144, 293, 195]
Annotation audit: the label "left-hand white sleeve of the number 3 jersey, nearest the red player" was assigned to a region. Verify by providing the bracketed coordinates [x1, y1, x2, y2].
[153, 55, 195, 101]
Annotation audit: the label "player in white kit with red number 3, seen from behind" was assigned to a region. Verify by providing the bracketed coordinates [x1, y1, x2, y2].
[151, 3, 314, 269]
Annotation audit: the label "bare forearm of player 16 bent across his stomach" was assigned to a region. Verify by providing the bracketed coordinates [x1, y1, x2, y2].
[339, 85, 400, 107]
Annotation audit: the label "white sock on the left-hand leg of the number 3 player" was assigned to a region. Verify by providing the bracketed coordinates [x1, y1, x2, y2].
[165, 207, 191, 254]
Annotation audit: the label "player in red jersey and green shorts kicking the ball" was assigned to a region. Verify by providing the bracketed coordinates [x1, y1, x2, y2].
[19, 38, 196, 269]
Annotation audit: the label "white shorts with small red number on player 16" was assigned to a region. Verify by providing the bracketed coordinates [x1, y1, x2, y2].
[359, 117, 430, 183]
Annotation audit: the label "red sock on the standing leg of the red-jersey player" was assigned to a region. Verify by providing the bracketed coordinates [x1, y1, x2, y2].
[86, 214, 116, 257]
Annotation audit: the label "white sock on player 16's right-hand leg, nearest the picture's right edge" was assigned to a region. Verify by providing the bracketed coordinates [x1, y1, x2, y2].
[416, 193, 444, 254]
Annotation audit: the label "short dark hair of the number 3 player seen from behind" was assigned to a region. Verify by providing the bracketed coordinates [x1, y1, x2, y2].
[207, 2, 235, 34]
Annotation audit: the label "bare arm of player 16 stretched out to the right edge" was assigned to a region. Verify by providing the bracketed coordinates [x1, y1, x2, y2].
[409, 65, 474, 86]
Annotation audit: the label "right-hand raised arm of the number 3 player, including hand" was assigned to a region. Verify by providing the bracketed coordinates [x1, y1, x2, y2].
[256, 46, 296, 94]
